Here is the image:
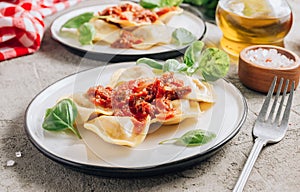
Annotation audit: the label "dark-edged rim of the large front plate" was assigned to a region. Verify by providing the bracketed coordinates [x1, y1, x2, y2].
[24, 62, 248, 178]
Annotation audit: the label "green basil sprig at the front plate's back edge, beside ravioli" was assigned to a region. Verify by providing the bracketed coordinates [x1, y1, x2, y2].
[136, 41, 230, 81]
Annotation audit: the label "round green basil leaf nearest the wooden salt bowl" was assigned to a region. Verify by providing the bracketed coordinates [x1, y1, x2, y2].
[199, 48, 230, 81]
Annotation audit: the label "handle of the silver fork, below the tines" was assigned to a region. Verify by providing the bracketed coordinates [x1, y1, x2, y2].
[233, 138, 267, 192]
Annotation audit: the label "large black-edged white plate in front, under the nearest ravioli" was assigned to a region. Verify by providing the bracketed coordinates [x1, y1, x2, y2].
[25, 63, 247, 176]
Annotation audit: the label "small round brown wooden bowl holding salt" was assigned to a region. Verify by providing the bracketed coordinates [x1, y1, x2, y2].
[238, 45, 300, 93]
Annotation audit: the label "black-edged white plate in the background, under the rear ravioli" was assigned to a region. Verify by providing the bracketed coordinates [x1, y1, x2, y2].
[51, 4, 206, 60]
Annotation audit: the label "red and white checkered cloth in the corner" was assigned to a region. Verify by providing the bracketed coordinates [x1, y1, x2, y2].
[0, 0, 81, 61]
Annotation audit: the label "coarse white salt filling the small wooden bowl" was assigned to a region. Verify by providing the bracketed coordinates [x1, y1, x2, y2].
[246, 48, 295, 69]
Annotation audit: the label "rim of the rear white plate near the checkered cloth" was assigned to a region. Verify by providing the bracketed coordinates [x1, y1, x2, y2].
[50, 3, 207, 61]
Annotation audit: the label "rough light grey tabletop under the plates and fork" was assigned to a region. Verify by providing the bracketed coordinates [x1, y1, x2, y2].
[0, 0, 300, 192]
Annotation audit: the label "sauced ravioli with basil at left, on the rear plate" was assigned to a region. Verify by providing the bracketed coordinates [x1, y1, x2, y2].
[60, 1, 189, 50]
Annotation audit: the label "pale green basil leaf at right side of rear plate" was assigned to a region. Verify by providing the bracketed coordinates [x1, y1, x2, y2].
[172, 28, 197, 46]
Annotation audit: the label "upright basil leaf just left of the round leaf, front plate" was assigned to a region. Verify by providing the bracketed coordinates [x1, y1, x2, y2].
[183, 41, 204, 67]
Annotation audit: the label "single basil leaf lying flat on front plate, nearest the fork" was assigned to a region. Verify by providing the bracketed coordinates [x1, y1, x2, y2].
[159, 129, 216, 147]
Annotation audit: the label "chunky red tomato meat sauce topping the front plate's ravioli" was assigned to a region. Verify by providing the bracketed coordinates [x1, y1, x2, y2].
[87, 73, 192, 133]
